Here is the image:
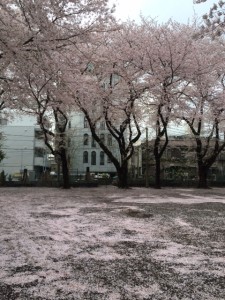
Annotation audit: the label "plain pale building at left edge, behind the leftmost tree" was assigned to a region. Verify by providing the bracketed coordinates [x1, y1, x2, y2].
[0, 116, 48, 180]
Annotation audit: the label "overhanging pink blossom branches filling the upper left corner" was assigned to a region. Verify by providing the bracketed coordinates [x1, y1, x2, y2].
[0, 0, 113, 109]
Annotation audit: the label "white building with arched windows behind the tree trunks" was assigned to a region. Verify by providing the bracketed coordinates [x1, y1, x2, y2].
[68, 113, 119, 175]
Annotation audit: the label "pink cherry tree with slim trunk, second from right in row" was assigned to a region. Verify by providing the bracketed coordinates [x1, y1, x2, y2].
[135, 20, 197, 188]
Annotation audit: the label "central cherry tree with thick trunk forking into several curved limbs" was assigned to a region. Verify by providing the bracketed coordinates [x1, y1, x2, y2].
[65, 25, 145, 188]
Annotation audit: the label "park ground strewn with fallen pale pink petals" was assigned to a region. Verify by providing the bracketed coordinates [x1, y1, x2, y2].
[0, 186, 225, 300]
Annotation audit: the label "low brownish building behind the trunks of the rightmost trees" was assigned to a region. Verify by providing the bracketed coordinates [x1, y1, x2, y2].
[139, 135, 225, 181]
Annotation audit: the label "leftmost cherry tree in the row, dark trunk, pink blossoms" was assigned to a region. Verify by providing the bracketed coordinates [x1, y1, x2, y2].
[11, 52, 70, 188]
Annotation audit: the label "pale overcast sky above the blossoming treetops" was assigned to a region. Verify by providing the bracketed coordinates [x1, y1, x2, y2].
[110, 0, 216, 23]
